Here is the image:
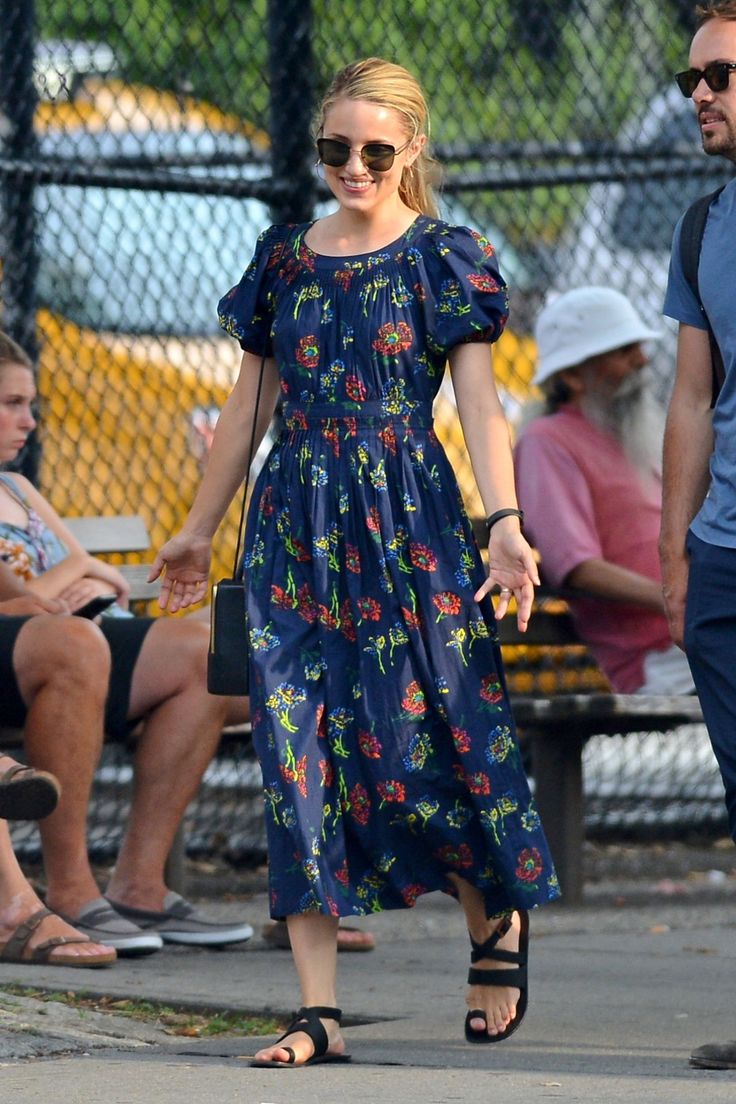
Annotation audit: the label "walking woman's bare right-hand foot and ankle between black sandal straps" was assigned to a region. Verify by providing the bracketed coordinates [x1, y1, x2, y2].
[449, 874, 521, 1036]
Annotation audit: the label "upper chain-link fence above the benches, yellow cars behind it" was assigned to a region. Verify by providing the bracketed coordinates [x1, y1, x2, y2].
[0, 0, 727, 856]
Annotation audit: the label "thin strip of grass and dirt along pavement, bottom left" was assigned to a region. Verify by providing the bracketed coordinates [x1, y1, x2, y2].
[0, 985, 284, 1039]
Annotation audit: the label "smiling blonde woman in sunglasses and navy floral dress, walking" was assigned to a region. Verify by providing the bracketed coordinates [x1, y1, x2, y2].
[154, 57, 558, 1068]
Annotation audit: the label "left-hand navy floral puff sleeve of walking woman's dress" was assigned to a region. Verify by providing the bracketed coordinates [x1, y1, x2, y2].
[217, 226, 287, 357]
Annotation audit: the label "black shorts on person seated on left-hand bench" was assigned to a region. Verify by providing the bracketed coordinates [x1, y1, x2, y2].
[0, 616, 154, 740]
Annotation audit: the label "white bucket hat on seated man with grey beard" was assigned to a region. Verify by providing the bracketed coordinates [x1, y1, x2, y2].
[532, 287, 662, 384]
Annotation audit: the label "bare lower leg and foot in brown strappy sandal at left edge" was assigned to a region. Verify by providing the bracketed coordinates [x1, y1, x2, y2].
[0, 820, 111, 965]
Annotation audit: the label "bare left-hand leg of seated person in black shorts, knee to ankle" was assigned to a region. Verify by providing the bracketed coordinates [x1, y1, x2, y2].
[13, 617, 109, 915]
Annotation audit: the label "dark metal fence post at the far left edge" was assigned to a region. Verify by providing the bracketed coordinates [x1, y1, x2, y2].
[0, 0, 40, 479]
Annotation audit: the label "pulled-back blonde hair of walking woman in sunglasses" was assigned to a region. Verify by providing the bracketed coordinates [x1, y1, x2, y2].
[313, 57, 439, 219]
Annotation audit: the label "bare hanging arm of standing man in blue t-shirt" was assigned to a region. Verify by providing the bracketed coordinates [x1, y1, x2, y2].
[660, 322, 713, 647]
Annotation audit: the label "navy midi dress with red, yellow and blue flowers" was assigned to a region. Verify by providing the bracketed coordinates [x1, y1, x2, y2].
[218, 215, 559, 916]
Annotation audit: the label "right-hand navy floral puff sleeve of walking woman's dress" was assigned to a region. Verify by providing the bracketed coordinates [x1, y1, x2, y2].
[426, 224, 509, 351]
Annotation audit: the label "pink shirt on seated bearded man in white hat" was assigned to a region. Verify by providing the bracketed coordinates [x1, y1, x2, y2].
[514, 406, 672, 693]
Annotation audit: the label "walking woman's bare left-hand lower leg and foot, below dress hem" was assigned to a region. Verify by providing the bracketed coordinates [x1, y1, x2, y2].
[255, 913, 345, 1065]
